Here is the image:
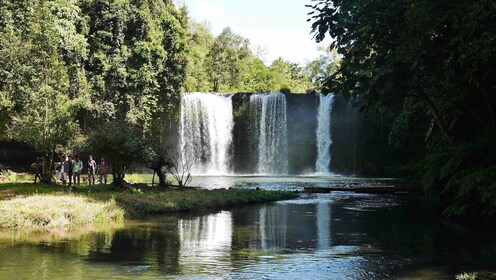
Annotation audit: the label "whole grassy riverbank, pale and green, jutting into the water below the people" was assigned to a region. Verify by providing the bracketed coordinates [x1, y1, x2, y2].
[0, 183, 297, 227]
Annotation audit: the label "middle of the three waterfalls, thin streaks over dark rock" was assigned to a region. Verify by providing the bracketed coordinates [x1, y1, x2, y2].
[250, 93, 288, 174]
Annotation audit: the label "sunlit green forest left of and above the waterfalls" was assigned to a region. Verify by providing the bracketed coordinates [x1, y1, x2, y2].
[0, 0, 337, 186]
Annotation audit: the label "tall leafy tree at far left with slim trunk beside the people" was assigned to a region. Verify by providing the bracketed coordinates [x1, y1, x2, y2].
[0, 1, 85, 183]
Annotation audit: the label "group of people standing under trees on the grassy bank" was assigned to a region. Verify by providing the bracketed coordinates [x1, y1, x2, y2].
[34, 155, 110, 186]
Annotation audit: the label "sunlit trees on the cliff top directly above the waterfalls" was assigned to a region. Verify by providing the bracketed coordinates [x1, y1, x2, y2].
[184, 22, 311, 92]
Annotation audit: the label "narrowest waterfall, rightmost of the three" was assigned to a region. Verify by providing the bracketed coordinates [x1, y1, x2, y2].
[315, 94, 334, 174]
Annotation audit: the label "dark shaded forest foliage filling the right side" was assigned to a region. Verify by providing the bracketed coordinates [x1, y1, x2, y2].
[309, 0, 496, 219]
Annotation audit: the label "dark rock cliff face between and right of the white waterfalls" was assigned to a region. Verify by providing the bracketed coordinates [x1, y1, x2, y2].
[227, 93, 410, 176]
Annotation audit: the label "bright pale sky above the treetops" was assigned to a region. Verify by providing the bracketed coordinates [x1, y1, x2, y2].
[179, 0, 330, 65]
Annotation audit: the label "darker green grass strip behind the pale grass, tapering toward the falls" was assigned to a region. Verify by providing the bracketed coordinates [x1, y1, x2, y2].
[0, 183, 297, 222]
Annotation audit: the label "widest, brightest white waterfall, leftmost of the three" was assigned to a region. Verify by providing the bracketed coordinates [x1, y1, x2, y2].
[180, 92, 234, 175]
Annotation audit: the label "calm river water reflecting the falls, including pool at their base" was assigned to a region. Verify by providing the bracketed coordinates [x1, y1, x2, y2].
[0, 177, 496, 279]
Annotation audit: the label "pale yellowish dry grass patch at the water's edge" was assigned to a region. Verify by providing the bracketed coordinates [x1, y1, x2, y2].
[0, 195, 124, 228]
